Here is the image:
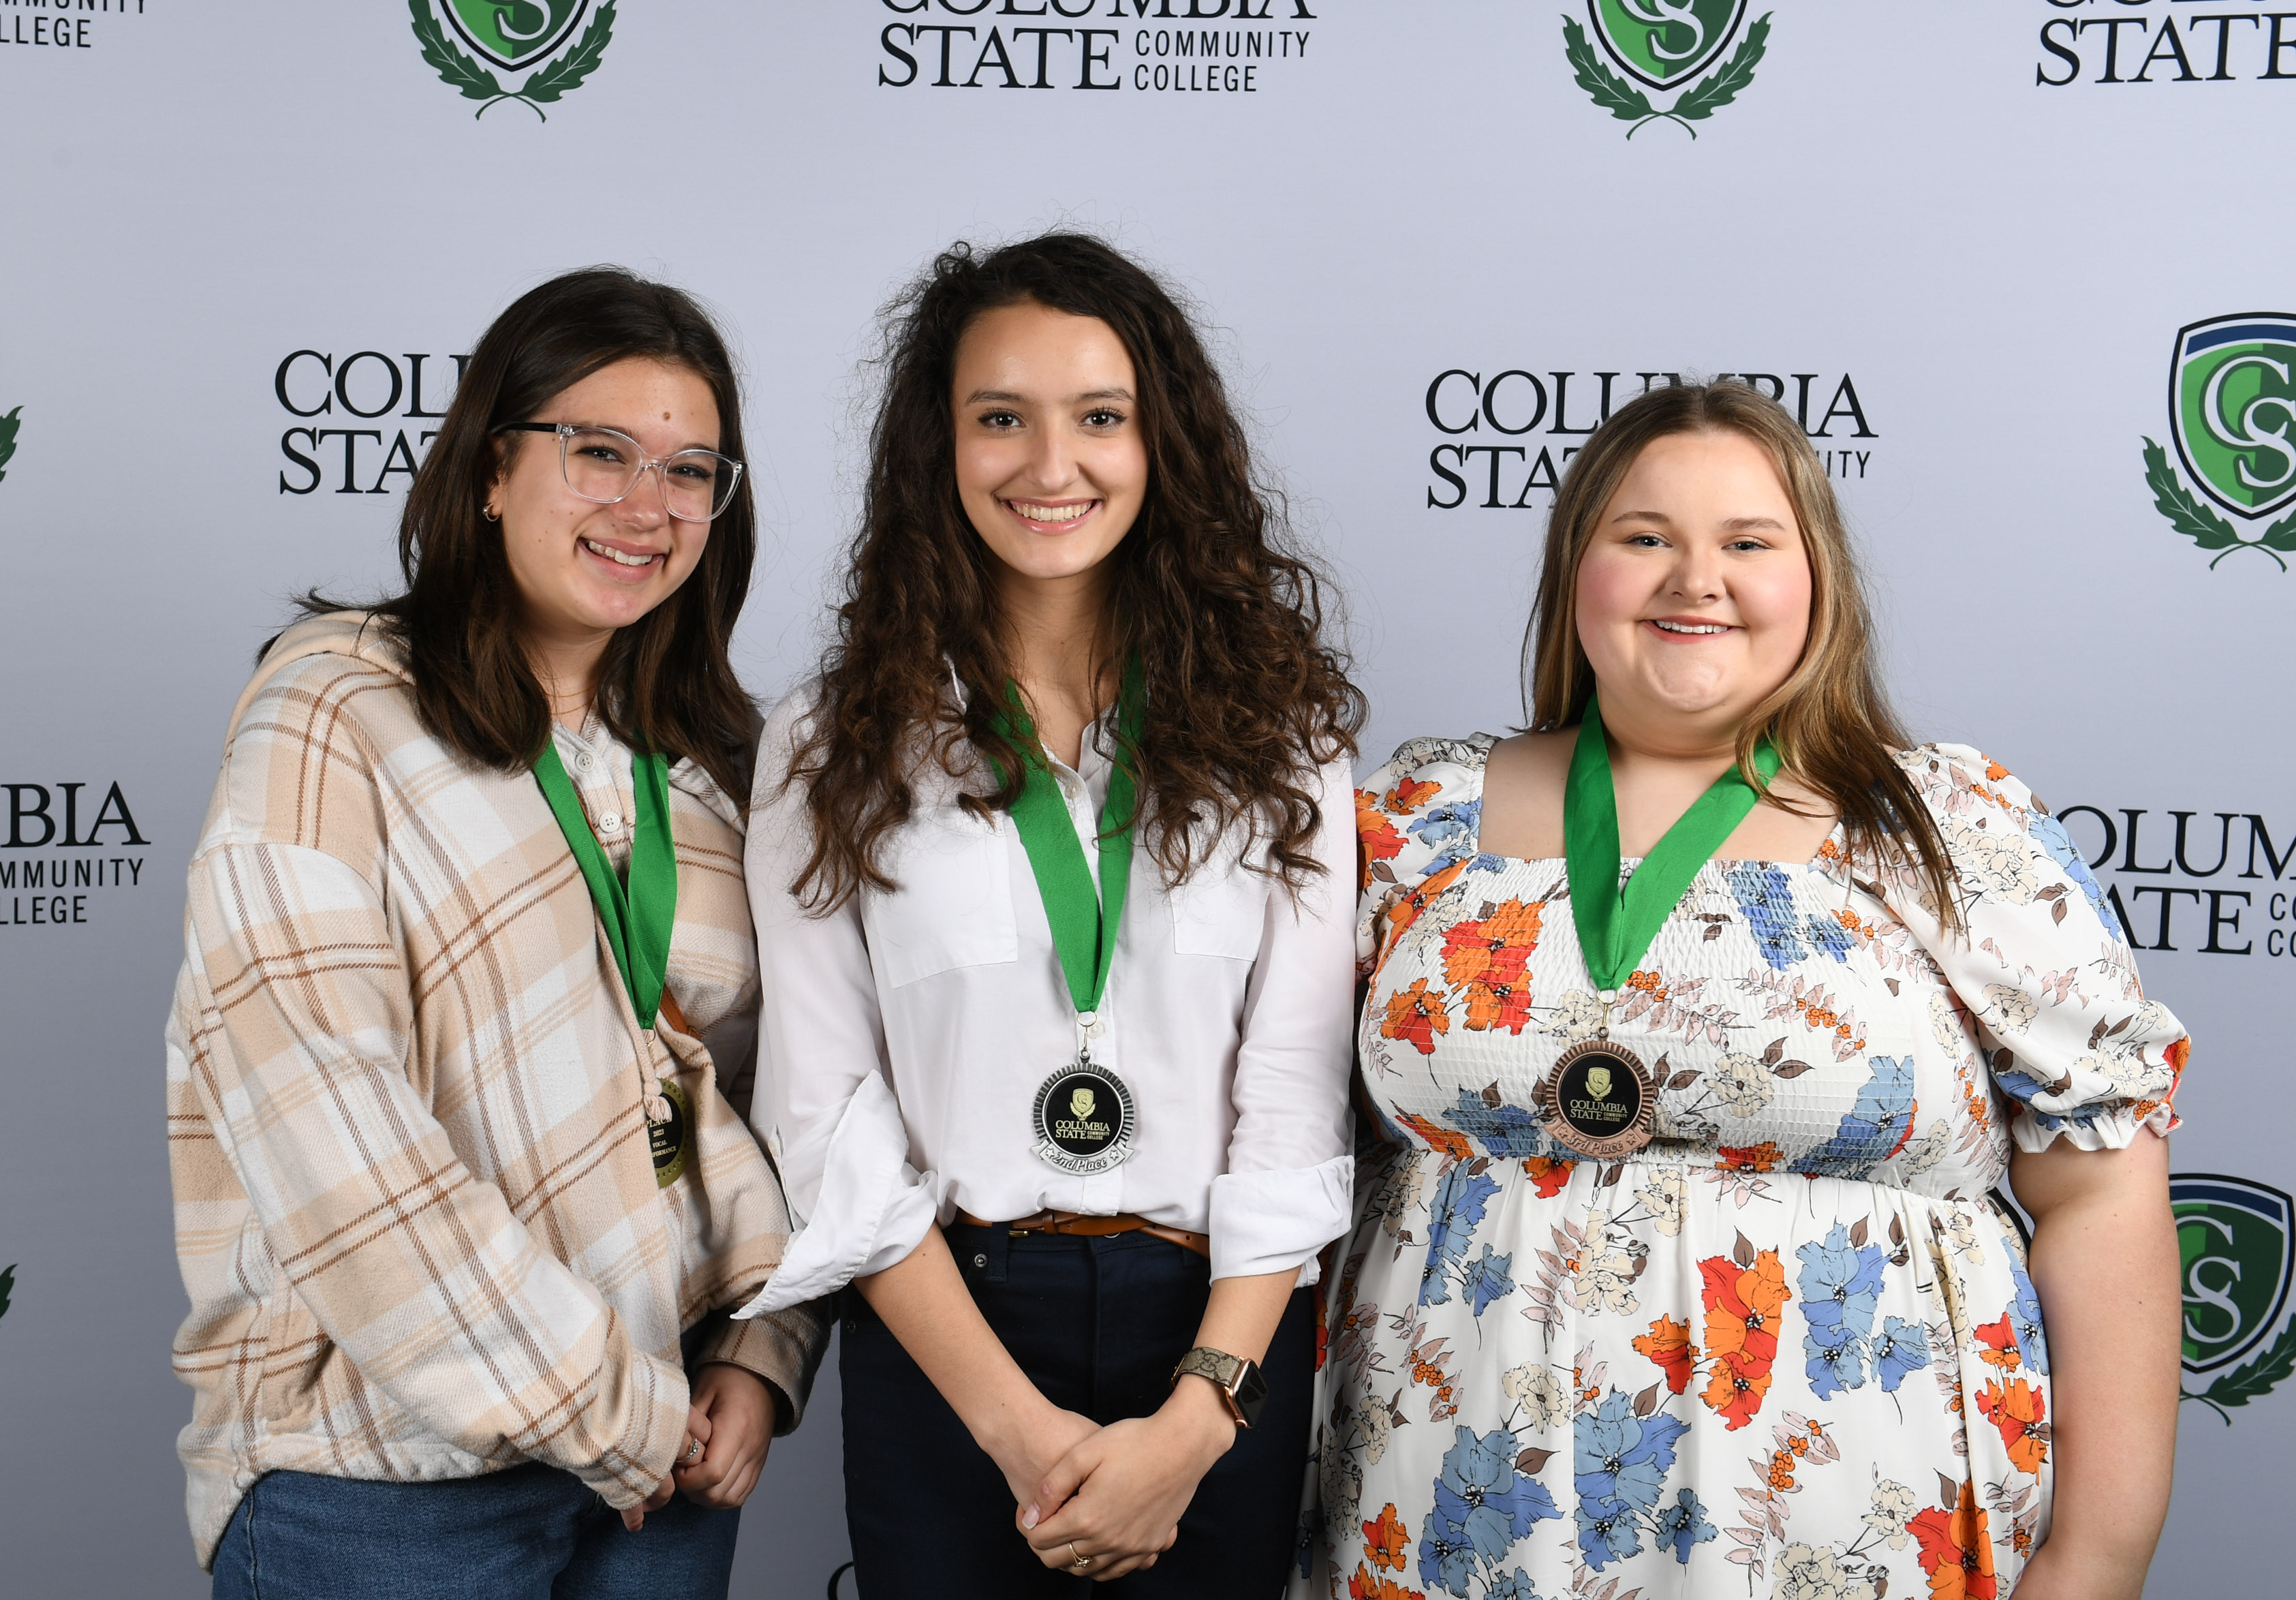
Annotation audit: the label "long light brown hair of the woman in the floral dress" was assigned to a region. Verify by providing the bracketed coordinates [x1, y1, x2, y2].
[1522, 384, 1961, 927]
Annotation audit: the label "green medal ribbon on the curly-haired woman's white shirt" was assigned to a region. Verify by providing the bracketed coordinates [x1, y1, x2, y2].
[997, 661, 1146, 1017]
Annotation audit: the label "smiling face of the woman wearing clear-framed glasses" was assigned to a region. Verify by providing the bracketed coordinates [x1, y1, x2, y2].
[486, 358, 719, 656]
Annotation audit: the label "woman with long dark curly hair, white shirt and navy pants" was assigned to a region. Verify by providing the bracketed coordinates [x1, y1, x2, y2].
[749, 234, 1361, 1600]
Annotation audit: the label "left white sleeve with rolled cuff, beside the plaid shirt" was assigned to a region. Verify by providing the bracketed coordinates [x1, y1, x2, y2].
[734, 696, 937, 1318]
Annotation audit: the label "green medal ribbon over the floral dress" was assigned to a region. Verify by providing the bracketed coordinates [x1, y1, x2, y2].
[1564, 698, 1784, 1003]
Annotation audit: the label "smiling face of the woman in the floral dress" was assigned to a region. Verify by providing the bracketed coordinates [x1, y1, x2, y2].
[1575, 431, 1812, 728]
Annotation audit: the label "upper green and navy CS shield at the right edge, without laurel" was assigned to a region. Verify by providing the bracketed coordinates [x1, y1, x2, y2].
[2167, 315, 2296, 517]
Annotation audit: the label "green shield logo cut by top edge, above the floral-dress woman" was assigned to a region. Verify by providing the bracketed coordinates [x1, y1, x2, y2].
[1564, 0, 1770, 138]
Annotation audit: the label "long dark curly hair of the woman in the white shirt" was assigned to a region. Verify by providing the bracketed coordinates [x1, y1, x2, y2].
[786, 232, 1364, 911]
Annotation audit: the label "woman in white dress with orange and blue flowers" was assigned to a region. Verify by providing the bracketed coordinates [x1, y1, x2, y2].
[1311, 386, 2186, 1600]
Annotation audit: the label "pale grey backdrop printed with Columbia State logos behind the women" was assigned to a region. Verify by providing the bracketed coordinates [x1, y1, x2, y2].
[0, 0, 2296, 1600]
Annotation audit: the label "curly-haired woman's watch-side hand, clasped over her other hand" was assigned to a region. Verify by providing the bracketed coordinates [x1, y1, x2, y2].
[1019, 1380, 1235, 1582]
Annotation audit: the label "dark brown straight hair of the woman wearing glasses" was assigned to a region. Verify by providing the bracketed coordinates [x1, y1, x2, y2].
[298, 266, 758, 799]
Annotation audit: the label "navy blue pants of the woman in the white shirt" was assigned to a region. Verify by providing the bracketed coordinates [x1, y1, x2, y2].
[838, 1228, 1316, 1600]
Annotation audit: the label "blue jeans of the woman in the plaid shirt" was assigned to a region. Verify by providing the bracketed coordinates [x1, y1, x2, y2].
[213, 1462, 742, 1600]
